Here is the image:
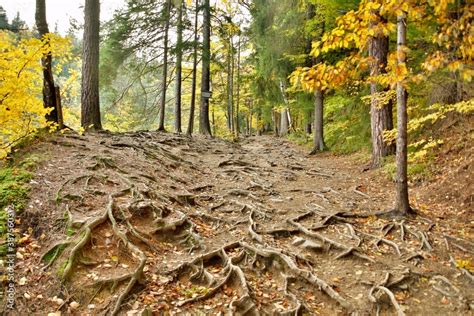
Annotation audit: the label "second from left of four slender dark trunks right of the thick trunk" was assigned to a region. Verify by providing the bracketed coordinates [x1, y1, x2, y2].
[174, 0, 183, 133]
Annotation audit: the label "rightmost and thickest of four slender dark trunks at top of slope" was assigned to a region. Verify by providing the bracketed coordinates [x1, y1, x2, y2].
[199, 0, 212, 136]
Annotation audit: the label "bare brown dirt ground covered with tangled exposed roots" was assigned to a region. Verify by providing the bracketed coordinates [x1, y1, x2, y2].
[3, 132, 474, 315]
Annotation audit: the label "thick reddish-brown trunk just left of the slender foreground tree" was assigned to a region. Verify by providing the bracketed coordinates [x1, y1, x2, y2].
[369, 10, 395, 167]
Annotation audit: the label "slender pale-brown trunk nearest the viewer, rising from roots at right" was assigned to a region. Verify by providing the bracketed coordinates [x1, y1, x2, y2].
[395, 13, 410, 215]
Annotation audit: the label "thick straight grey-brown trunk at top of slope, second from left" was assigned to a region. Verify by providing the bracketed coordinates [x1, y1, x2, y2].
[81, 0, 102, 130]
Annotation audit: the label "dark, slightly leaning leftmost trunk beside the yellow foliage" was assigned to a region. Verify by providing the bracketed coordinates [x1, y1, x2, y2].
[35, 0, 59, 123]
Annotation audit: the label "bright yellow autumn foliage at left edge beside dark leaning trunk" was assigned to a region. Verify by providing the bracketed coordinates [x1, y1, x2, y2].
[0, 31, 71, 159]
